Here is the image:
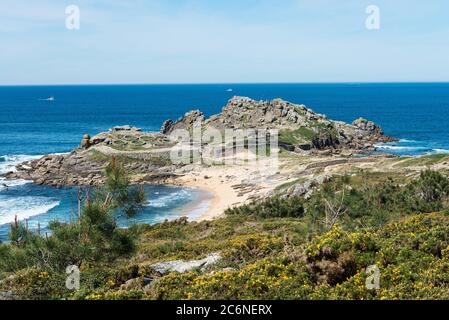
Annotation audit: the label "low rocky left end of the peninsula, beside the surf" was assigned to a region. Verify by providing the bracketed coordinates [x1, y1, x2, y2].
[4, 128, 175, 187]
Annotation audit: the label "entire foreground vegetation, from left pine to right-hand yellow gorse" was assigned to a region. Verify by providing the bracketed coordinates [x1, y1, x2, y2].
[0, 163, 449, 299]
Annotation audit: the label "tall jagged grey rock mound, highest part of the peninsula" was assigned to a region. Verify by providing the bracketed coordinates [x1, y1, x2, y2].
[161, 97, 394, 151]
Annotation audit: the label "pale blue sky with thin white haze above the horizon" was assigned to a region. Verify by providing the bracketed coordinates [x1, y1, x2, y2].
[0, 0, 449, 84]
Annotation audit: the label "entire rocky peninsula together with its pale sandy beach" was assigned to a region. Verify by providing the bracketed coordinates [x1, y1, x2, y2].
[4, 97, 395, 218]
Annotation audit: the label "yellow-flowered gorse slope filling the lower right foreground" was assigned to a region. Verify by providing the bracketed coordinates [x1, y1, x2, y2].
[149, 213, 449, 300]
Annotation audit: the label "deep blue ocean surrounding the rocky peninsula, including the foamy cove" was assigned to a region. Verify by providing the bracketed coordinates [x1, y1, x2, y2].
[0, 83, 449, 240]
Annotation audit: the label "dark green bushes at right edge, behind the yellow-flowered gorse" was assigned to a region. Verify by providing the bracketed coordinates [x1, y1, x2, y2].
[307, 171, 449, 231]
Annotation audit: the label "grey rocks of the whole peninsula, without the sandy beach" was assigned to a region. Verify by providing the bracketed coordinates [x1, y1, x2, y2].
[3, 97, 395, 187]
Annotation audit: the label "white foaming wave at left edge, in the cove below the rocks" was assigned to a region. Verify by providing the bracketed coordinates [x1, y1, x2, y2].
[0, 196, 60, 225]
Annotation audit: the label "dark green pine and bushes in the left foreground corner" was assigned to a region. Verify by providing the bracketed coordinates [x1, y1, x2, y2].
[0, 159, 145, 299]
